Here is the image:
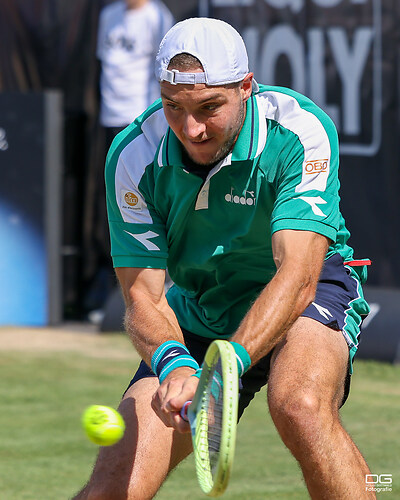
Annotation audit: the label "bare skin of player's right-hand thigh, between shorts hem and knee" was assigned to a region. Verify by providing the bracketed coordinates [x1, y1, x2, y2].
[268, 317, 349, 413]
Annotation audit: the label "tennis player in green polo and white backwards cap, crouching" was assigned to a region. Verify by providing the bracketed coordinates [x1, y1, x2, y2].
[76, 18, 373, 500]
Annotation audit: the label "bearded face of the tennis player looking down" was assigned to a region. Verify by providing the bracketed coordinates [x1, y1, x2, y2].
[161, 70, 251, 165]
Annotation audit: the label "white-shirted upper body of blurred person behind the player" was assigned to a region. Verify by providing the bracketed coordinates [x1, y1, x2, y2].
[97, 0, 174, 149]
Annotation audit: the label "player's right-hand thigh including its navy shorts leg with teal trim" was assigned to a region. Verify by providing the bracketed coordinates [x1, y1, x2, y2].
[269, 254, 368, 410]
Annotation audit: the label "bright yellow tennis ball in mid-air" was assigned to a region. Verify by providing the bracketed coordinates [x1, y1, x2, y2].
[82, 405, 125, 446]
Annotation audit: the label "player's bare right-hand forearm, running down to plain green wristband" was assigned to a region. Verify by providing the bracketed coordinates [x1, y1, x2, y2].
[231, 267, 316, 365]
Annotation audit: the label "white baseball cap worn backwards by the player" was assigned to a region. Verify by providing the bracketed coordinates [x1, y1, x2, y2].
[155, 17, 258, 92]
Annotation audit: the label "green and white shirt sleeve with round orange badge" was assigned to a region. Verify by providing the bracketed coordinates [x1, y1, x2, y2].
[106, 129, 168, 269]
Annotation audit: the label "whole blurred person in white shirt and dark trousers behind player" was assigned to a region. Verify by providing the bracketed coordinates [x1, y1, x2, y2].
[84, 0, 174, 316]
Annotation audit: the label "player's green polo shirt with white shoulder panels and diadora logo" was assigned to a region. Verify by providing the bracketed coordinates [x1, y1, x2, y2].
[106, 86, 353, 338]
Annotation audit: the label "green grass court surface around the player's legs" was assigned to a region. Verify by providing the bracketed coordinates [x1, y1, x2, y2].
[0, 332, 400, 500]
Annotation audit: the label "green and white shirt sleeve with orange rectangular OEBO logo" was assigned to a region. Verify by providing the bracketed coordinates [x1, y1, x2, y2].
[271, 105, 340, 241]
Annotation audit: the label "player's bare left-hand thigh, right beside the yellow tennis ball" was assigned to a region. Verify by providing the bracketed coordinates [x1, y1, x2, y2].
[83, 377, 192, 499]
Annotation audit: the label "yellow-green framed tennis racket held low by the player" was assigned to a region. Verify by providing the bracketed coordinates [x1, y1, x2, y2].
[181, 340, 239, 497]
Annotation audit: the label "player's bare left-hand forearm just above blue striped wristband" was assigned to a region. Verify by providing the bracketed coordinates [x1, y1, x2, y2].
[125, 293, 184, 366]
